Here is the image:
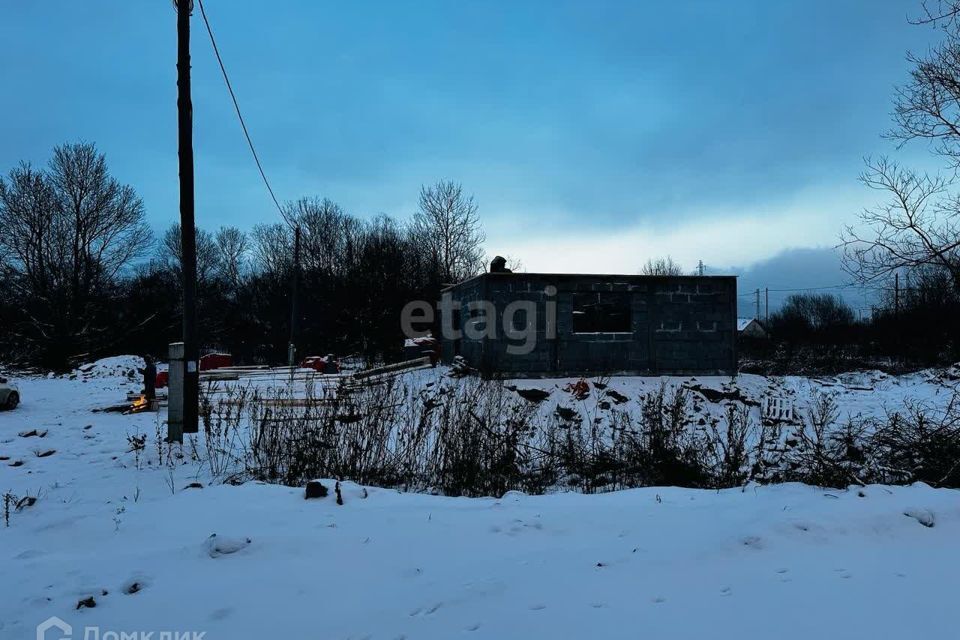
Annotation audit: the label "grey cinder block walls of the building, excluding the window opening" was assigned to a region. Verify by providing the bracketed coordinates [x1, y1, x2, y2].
[443, 273, 737, 377]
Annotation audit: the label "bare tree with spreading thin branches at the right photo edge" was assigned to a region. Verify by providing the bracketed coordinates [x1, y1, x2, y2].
[841, 5, 960, 291]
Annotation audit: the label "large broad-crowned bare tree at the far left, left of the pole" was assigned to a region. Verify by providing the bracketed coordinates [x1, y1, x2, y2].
[0, 143, 152, 364]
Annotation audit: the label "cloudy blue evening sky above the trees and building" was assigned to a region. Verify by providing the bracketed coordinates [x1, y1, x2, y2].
[0, 0, 936, 300]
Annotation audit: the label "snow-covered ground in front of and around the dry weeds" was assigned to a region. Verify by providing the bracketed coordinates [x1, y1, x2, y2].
[0, 362, 960, 640]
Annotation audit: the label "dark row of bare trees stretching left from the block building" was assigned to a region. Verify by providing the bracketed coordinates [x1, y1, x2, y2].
[0, 143, 485, 369]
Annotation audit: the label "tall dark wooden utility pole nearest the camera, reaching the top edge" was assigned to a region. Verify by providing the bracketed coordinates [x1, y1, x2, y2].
[175, 0, 200, 441]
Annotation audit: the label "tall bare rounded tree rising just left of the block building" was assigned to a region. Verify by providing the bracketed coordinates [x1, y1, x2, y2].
[412, 180, 486, 282]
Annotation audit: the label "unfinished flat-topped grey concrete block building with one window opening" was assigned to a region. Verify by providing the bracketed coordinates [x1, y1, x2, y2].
[441, 272, 737, 377]
